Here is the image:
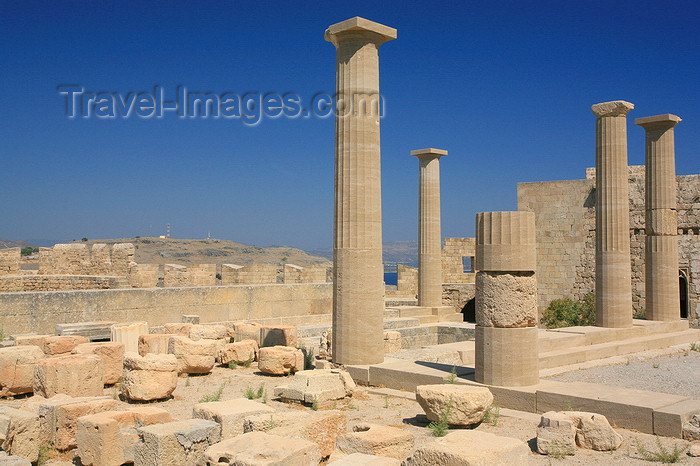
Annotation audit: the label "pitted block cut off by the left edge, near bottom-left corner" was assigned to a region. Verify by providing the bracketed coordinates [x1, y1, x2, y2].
[0, 406, 41, 464]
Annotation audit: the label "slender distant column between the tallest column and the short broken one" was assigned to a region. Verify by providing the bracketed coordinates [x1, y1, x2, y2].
[411, 149, 447, 307]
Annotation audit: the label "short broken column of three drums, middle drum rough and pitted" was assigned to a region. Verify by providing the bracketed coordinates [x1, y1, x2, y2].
[475, 211, 539, 387]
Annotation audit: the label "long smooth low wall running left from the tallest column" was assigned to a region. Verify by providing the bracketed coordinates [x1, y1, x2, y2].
[0, 283, 333, 335]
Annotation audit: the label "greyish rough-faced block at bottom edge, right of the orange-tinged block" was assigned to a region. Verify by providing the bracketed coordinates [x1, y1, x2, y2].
[134, 419, 221, 466]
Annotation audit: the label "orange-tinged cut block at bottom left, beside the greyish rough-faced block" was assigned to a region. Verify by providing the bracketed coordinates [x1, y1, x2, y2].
[76, 406, 174, 466]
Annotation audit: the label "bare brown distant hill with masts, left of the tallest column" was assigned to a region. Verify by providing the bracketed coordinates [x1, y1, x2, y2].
[77, 237, 331, 266]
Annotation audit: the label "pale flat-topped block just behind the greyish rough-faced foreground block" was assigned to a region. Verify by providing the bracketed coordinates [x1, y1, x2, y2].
[192, 398, 275, 439]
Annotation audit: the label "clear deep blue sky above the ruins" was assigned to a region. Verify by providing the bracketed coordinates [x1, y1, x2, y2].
[0, 0, 700, 248]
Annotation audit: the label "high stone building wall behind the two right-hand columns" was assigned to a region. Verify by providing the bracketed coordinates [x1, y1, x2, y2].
[518, 166, 700, 325]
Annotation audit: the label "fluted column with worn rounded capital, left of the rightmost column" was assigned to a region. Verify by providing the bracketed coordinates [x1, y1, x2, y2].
[591, 100, 634, 327]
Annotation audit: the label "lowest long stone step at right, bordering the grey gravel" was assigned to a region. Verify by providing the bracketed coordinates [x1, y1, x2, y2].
[540, 329, 700, 370]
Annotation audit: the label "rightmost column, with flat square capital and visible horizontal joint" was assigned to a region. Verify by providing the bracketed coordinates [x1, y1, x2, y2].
[634, 114, 681, 320]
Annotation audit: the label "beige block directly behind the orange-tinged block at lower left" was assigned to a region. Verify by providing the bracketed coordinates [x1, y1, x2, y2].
[38, 396, 122, 451]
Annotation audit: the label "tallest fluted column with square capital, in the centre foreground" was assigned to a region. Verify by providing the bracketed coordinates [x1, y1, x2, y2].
[325, 17, 396, 365]
